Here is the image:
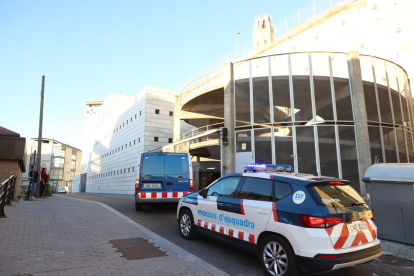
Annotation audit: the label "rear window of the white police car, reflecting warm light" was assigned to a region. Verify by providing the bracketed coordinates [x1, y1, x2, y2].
[310, 185, 365, 208]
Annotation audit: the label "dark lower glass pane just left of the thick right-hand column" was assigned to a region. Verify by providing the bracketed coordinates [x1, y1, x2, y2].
[338, 126, 360, 192]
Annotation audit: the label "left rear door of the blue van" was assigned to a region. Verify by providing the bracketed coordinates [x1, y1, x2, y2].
[140, 154, 165, 192]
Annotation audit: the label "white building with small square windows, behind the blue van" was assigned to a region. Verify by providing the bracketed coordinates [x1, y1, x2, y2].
[83, 86, 178, 194]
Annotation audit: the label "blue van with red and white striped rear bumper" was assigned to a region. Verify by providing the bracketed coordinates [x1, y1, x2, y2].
[135, 152, 194, 211]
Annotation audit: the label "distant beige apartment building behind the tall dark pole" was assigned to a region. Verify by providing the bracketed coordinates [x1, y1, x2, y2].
[23, 138, 82, 191]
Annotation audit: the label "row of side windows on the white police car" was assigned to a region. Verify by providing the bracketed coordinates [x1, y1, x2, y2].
[207, 177, 293, 201]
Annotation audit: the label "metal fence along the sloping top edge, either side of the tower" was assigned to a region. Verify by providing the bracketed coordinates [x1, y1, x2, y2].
[180, 0, 359, 91]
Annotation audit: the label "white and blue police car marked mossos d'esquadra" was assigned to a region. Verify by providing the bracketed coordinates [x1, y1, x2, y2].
[177, 164, 382, 275]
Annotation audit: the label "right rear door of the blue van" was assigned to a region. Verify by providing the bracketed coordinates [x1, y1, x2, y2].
[165, 153, 190, 192]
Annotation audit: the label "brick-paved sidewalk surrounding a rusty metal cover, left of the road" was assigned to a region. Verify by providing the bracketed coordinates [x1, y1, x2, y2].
[0, 195, 227, 276]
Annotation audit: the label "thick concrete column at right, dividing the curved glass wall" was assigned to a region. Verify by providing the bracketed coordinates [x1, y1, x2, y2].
[348, 52, 371, 195]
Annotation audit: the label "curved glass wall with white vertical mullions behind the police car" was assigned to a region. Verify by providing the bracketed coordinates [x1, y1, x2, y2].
[234, 53, 414, 193]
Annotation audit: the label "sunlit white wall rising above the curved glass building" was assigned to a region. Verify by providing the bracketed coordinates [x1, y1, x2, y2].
[262, 0, 414, 78]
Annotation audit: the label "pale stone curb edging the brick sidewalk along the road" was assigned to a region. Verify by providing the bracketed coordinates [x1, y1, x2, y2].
[57, 195, 229, 276]
